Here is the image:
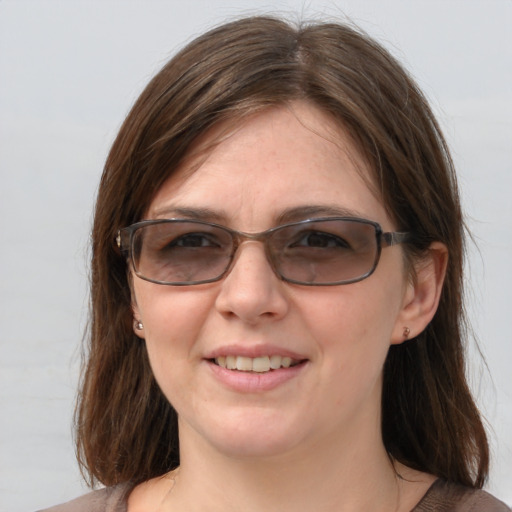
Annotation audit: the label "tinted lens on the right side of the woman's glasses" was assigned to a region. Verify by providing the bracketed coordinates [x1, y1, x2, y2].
[269, 220, 378, 284]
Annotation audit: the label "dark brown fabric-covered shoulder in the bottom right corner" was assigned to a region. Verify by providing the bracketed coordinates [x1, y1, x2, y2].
[412, 479, 511, 512]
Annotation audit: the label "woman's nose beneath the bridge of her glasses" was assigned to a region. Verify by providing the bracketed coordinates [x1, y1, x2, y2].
[216, 241, 288, 324]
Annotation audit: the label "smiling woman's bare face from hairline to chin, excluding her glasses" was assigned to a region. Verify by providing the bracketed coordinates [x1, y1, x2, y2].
[133, 102, 409, 456]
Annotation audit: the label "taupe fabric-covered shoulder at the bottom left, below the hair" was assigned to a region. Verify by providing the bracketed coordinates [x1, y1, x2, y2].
[36, 484, 130, 512]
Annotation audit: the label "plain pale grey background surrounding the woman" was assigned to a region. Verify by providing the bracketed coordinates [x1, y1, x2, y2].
[0, 0, 512, 512]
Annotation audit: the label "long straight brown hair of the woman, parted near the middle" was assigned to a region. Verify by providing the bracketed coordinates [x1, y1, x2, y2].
[76, 17, 488, 487]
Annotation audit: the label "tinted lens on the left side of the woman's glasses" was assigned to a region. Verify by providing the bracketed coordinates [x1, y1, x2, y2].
[132, 221, 233, 284]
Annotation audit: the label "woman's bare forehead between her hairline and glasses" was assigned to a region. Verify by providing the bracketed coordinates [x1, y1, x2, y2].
[148, 102, 383, 229]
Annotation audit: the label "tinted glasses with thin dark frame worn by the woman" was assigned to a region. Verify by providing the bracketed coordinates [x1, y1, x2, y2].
[117, 217, 410, 286]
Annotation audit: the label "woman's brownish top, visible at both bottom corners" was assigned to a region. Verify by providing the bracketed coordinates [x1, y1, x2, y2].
[40, 479, 512, 512]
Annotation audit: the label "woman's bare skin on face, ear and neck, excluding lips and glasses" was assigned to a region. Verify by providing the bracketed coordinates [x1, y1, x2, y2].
[129, 102, 446, 512]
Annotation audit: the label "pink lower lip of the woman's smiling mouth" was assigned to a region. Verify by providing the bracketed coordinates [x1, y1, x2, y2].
[207, 361, 307, 393]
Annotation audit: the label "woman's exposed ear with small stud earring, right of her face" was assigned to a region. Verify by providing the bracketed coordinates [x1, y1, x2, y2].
[391, 242, 448, 345]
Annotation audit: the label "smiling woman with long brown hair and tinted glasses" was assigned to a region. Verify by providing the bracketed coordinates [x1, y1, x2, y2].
[40, 17, 508, 512]
